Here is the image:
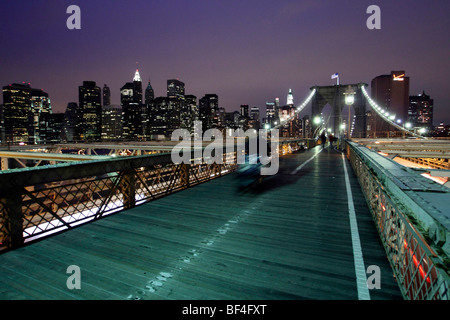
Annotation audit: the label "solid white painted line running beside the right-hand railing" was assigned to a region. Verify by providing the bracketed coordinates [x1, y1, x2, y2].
[342, 154, 370, 300]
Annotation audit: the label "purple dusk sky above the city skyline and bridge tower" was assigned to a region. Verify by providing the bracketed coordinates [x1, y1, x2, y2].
[0, 0, 450, 124]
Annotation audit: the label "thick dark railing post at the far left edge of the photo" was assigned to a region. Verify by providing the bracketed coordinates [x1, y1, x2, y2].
[0, 190, 24, 248]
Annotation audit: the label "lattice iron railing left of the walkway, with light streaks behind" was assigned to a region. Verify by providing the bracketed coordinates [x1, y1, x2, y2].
[0, 152, 236, 249]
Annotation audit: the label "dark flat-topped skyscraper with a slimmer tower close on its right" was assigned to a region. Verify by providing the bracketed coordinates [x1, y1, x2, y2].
[78, 81, 102, 141]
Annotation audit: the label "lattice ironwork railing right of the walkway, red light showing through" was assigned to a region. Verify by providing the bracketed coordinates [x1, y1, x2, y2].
[347, 145, 450, 300]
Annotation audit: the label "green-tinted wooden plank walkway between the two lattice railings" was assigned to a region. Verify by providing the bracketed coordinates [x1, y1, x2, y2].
[0, 146, 402, 300]
